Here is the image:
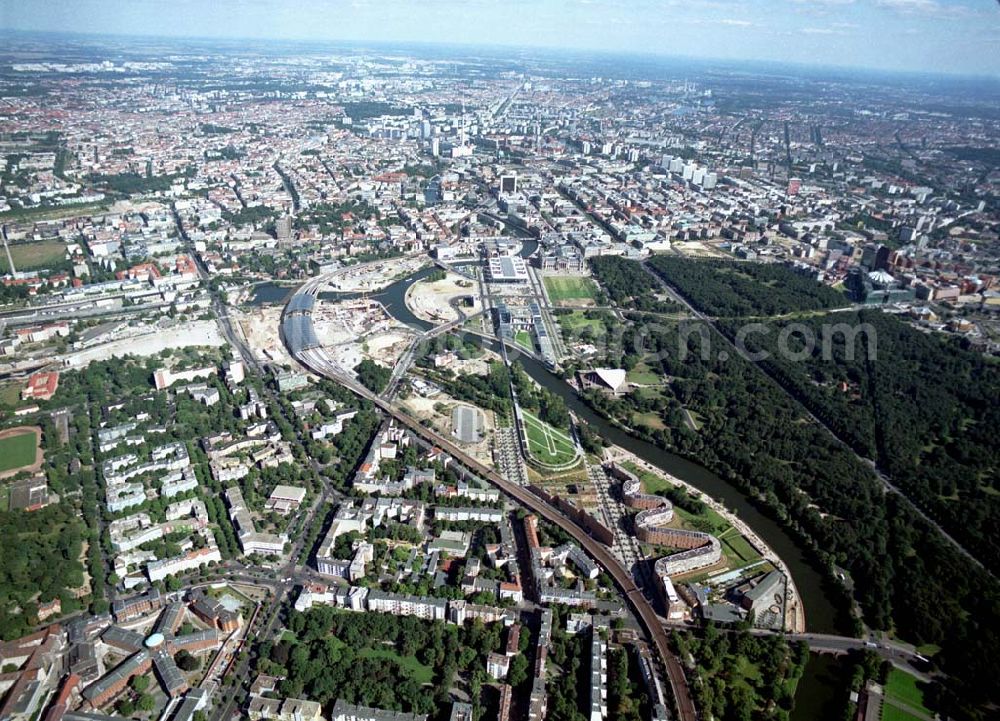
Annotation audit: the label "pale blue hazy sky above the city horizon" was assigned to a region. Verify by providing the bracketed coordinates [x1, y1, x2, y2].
[0, 0, 1000, 76]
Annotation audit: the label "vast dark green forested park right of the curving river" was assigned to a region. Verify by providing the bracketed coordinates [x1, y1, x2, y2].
[586, 258, 1000, 718]
